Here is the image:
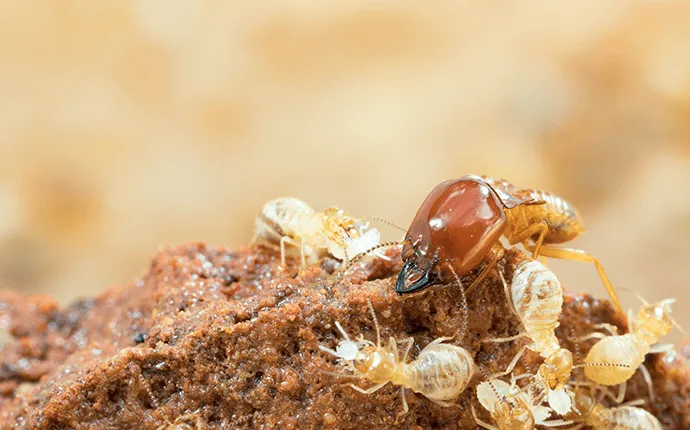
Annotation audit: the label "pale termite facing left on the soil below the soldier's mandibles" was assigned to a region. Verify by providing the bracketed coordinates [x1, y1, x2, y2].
[319, 301, 475, 414]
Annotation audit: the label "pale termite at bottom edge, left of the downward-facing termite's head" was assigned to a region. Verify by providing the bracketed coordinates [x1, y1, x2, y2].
[472, 379, 551, 430]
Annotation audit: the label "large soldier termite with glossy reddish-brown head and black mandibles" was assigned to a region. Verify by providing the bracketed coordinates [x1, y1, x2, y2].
[395, 175, 621, 309]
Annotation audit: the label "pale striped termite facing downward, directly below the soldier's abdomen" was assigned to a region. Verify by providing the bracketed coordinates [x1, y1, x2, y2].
[484, 258, 627, 415]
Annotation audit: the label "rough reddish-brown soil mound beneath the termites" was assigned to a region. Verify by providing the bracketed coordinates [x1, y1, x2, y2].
[0, 243, 690, 430]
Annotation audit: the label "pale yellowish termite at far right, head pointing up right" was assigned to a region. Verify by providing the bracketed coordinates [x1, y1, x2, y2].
[585, 299, 677, 386]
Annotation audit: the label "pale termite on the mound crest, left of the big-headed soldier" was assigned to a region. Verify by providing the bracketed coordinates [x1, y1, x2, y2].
[253, 197, 380, 267]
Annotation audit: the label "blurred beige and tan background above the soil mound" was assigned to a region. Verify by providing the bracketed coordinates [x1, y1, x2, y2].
[0, 0, 690, 340]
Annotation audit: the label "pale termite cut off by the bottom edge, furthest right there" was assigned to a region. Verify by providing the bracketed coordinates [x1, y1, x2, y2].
[554, 389, 662, 430]
